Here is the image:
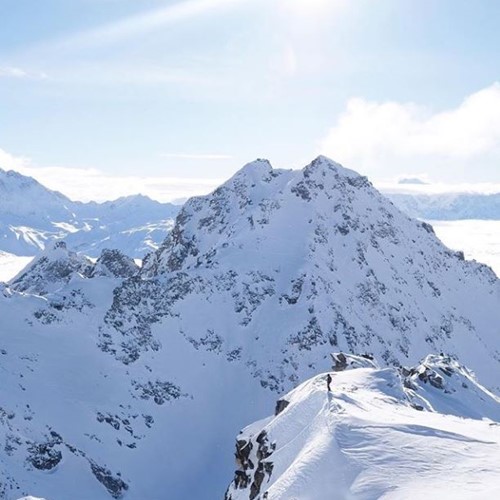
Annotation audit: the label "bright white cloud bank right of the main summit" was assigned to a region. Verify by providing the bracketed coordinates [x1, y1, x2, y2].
[321, 83, 500, 181]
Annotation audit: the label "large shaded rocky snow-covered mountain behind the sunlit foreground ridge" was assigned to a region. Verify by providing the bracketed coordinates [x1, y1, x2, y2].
[0, 157, 500, 500]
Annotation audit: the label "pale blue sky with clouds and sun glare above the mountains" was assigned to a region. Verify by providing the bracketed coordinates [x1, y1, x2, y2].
[0, 0, 500, 198]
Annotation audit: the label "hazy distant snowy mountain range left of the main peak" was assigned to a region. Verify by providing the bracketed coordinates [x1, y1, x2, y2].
[0, 169, 180, 258]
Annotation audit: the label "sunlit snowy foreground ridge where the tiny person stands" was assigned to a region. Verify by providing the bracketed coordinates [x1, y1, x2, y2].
[226, 356, 500, 500]
